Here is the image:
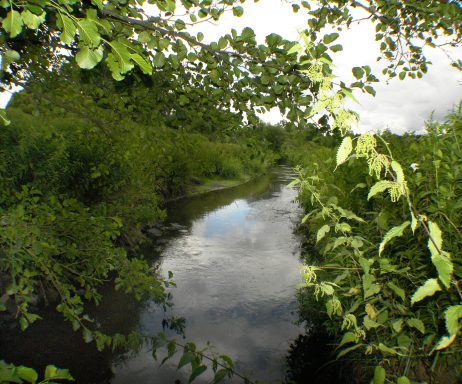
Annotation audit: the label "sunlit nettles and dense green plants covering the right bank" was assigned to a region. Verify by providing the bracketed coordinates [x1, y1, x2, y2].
[297, 110, 462, 383]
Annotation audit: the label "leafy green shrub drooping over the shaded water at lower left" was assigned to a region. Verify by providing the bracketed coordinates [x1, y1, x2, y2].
[0, 186, 167, 334]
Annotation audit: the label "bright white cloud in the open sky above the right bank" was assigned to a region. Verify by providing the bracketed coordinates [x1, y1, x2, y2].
[334, 16, 462, 133]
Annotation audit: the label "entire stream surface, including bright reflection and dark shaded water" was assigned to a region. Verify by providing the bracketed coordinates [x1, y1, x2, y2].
[0, 167, 301, 384]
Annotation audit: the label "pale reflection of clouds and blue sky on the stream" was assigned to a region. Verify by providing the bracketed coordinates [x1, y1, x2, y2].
[115, 170, 300, 383]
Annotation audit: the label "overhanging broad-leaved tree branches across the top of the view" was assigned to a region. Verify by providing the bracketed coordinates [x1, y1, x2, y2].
[0, 0, 462, 130]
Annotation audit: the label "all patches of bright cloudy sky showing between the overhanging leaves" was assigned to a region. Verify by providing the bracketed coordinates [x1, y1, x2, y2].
[0, 0, 462, 133]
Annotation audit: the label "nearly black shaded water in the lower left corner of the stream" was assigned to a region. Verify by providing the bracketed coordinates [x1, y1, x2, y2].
[0, 286, 142, 384]
